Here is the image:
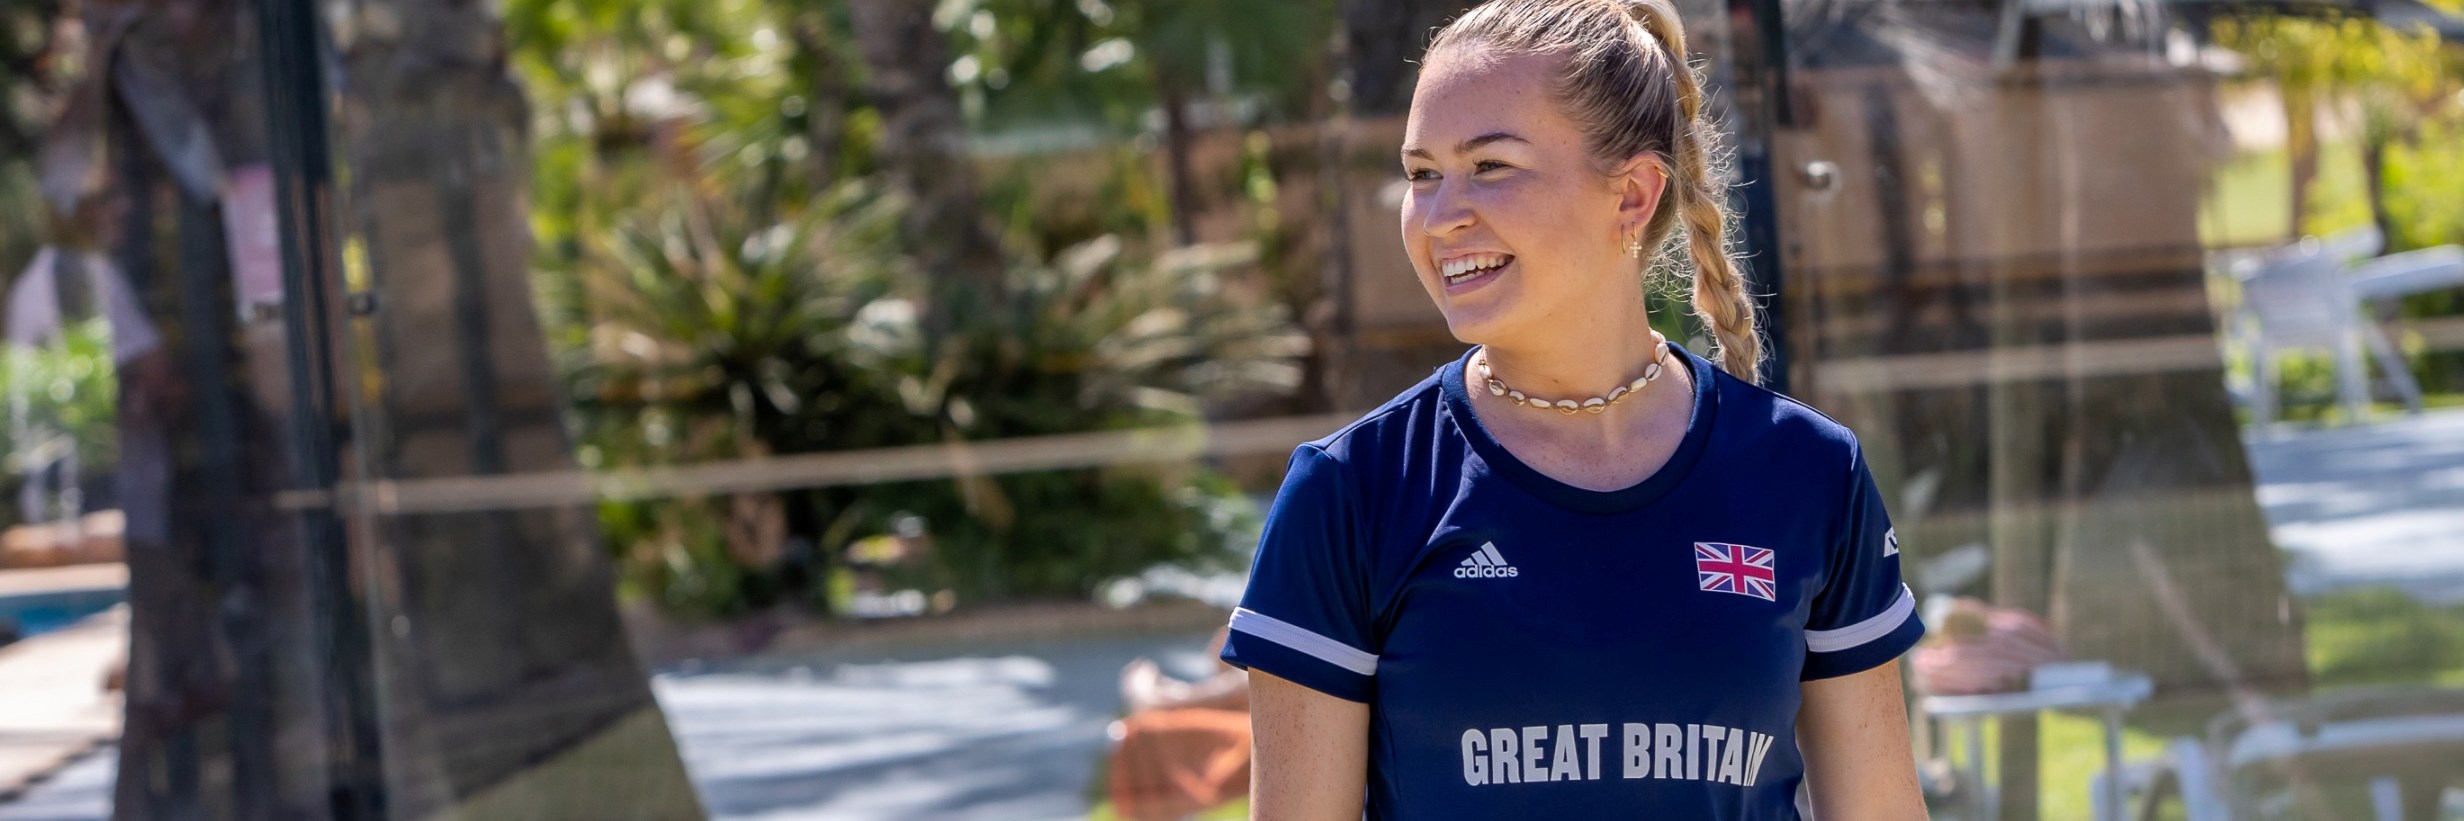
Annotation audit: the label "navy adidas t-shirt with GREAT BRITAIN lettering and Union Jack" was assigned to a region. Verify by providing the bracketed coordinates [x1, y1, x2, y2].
[1222, 345, 1924, 819]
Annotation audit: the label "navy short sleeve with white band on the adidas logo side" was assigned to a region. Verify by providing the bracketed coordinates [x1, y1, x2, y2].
[1222, 444, 1377, 703]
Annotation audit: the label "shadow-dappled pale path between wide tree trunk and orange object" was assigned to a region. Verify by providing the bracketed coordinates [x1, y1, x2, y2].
[653, 623, 1212, 821]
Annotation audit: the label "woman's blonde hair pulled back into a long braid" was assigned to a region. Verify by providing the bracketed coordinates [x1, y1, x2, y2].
[1424, 0, 1762, 382]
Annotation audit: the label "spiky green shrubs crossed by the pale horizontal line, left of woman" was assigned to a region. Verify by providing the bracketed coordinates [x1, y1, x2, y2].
[540, 182, 1306, 614]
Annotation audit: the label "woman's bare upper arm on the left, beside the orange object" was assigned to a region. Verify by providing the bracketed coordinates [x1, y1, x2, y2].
[1249, 671, 1370, 821]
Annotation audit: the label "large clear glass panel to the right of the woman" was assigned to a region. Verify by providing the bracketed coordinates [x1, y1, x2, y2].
[1772, 2, 2464, 819]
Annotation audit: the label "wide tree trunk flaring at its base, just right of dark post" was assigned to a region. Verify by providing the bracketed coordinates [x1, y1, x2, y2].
[335, 0, 700, 819]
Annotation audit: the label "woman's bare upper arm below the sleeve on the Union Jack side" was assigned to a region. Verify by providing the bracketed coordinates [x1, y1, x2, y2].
[1796, 661, 1924, 821]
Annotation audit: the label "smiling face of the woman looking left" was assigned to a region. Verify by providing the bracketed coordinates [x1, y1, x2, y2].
[1402, 49, 1658, 345]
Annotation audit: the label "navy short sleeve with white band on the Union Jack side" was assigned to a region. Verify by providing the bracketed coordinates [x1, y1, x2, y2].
[1799, 443, 1924, 680]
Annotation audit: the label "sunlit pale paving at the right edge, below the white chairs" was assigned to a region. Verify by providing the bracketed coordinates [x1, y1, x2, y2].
[2250, 409, 2464, 604]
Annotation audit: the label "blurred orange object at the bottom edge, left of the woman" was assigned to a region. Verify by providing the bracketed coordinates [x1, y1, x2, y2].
[1111, 708, 1249, 821]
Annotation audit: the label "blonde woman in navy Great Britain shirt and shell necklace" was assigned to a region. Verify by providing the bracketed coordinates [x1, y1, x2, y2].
[1222, 0, 1924, 821]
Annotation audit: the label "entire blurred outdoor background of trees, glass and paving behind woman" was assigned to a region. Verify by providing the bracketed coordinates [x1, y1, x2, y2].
[0, 0, 2464, 821]
